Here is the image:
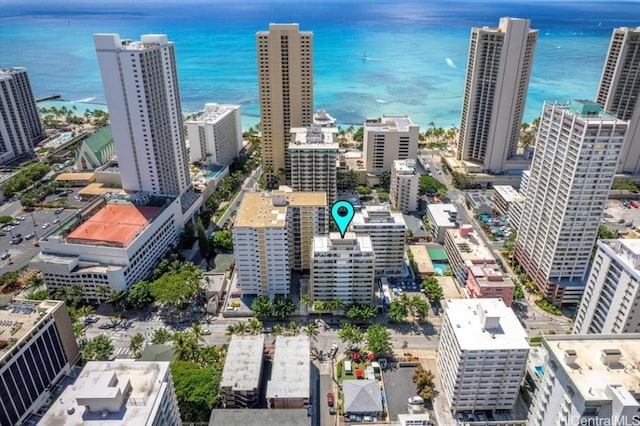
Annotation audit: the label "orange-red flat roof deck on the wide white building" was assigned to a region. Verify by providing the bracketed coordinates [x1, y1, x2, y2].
[65, 203, 162, 248]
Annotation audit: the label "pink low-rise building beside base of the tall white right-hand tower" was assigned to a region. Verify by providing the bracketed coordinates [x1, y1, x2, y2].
[465, 263, 515, 306]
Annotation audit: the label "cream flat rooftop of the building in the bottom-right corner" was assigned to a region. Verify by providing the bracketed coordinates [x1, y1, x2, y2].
[543, 333, 640, 401]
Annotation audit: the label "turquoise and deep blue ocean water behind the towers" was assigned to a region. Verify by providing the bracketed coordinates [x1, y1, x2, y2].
[0, 0, 640, 128]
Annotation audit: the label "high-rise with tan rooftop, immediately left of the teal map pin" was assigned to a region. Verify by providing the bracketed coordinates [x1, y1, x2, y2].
[233, 188, 328, 298]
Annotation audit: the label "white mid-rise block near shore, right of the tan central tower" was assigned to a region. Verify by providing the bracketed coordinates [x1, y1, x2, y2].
[362, 115, 420, 175]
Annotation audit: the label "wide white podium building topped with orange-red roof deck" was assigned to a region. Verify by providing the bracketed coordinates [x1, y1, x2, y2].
[30, 193, 183, 302]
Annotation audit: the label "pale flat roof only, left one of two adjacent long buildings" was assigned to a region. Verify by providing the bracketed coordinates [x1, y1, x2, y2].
[220, 334, 265, 391]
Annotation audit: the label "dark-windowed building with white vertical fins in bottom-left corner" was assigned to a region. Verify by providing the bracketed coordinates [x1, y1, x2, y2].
[0, 299, 80, 425]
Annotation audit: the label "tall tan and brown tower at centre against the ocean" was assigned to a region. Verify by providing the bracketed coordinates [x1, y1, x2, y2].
[256, 24, 313, 183]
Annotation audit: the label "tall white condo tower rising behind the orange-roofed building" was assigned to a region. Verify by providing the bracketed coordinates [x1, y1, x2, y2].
[93, 34, 190, 196]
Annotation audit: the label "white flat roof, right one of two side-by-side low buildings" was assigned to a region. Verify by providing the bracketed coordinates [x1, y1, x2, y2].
[266, 334, 311, 398]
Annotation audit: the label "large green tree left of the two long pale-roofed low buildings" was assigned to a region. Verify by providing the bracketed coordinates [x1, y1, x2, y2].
[170, 361, 224, 422]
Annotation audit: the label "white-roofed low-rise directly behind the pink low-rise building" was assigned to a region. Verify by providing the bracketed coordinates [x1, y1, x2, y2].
[444, 225, 496, 285]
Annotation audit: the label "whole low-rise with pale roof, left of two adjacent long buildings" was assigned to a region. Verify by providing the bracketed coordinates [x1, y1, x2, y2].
[220, 334, 264, 408]
